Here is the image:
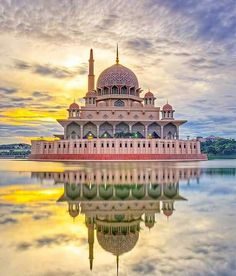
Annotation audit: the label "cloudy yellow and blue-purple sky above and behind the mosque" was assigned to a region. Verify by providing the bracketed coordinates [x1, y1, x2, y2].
[0, 0, 236, 144]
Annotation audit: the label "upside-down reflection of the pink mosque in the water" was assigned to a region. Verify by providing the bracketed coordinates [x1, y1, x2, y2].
[31, 163, 201, 273]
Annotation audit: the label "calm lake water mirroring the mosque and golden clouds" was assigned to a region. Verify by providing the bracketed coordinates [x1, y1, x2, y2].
[0, 160, 236, 276]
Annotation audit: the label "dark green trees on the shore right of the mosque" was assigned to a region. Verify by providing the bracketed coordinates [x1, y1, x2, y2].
[201, 138, 236, 155]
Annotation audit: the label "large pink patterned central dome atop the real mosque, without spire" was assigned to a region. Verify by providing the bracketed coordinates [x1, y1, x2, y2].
[97, 64, 139, 90]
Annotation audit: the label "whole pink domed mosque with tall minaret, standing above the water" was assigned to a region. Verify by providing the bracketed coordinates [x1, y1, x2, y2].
[30, 46, 206, 160]
